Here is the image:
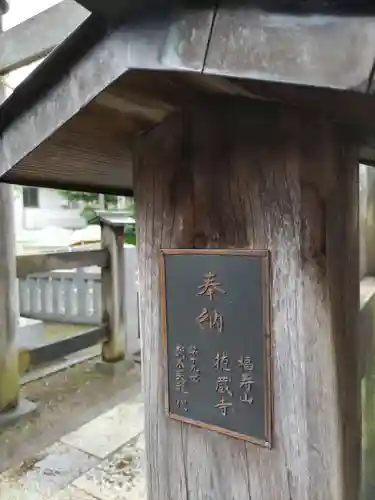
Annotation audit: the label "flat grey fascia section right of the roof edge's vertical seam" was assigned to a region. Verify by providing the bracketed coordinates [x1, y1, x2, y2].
[203, 9, 375, 92]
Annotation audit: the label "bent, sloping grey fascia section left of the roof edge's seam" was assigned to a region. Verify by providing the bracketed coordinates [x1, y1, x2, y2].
[0, 10, 213, 185]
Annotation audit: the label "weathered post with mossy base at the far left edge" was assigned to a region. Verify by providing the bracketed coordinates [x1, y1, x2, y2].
[0, 14, 19, 414]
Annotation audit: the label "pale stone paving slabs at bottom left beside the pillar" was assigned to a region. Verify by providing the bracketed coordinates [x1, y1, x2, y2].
[0, 395, 146, 500]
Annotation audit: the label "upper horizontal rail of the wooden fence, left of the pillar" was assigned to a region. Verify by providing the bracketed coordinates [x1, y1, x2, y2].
[17, 250, 109, 278]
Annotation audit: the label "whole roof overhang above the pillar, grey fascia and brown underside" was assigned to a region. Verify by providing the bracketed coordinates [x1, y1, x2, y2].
[0, 7, 375, 193]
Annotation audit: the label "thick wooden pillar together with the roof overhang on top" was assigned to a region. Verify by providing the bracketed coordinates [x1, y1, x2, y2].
[0, 1, 375, 500]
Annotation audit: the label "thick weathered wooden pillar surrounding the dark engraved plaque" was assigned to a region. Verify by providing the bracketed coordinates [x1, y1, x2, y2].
[134, 100, 361, 500]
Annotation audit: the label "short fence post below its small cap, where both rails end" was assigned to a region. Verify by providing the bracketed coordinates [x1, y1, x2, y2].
[101, 222, 126, 363]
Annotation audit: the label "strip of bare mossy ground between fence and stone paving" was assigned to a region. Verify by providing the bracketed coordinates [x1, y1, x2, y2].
[0, 358, 141, 472]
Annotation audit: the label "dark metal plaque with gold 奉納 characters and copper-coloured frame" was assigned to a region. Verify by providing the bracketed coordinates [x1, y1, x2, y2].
[160, 250, 271, 447]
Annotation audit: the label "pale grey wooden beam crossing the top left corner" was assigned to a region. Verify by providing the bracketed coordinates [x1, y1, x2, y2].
[0, 0, 90, 75]
